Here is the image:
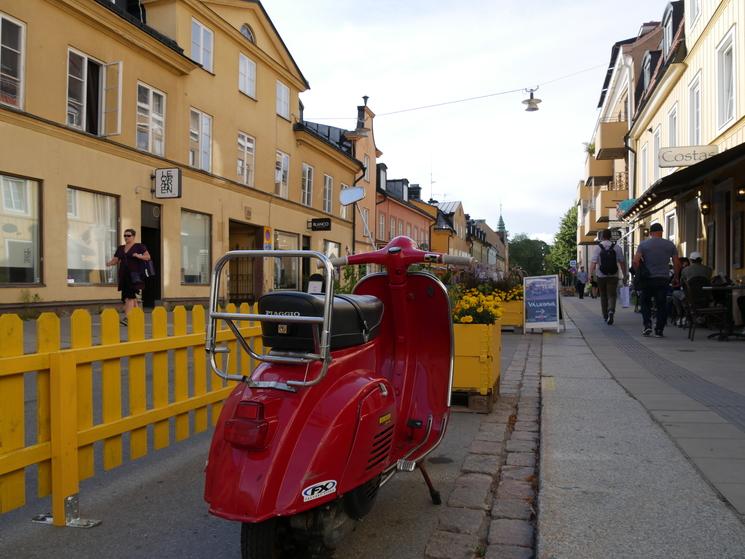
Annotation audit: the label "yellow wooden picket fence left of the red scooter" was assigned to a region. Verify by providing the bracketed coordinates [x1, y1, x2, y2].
[0, 304, 262, 526]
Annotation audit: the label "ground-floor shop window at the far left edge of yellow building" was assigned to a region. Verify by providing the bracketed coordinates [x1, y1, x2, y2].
[0, 175, 41, 285]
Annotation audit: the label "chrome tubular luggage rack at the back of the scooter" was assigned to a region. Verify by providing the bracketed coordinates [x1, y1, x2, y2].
[204, 250, 334, 392]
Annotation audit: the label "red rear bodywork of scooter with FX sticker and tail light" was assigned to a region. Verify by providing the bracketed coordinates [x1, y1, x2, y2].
[205, 342, 395, 522]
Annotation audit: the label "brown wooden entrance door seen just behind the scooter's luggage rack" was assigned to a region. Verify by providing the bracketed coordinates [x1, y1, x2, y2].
[228, 220, 264, 305]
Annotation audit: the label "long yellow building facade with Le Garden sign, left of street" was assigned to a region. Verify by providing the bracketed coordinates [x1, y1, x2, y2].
[0, 0, 360, 309]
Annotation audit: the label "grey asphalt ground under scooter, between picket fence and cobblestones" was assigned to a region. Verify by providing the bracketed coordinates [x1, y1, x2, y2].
[0, 413, 480, 559]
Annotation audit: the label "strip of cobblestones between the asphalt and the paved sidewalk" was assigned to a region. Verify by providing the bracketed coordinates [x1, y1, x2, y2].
[425, 335, 542, 559]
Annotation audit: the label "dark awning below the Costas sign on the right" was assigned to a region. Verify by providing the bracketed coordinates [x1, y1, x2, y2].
[623, 144, 745, 220]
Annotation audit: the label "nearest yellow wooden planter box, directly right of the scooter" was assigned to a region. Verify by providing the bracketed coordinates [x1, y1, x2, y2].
[453, 321, 502, 398]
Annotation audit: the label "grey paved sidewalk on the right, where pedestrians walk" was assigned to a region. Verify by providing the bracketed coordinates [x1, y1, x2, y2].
[537, 299, 745, 559]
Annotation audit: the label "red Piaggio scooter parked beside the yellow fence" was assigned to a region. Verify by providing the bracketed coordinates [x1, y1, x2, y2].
[204, 237, 471, 559]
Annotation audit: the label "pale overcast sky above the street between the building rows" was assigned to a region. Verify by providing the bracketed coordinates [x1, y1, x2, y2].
[263, 0, 667, 242]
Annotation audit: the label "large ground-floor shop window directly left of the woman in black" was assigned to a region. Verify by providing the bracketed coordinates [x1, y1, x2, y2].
[67, 187, 118, 285]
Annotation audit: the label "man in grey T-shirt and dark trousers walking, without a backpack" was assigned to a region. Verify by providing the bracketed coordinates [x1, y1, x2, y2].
[634, 223, 680, 338]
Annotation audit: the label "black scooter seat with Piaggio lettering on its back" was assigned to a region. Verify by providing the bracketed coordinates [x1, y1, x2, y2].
[259, 291, 383, 352]
